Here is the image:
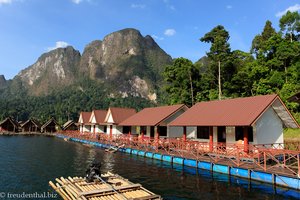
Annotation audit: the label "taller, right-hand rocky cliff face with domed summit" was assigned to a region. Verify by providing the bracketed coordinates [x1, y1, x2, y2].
[80, 29, 171, 100]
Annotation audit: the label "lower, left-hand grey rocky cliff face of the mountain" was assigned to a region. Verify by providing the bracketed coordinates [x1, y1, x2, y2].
[15, 46, 81, 95]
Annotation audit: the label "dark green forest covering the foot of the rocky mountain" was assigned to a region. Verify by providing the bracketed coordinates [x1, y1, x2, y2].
[0, 78, 153, 124]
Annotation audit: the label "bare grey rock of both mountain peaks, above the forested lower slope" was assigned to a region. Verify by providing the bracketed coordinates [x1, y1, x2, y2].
[14, 29, 171, 101]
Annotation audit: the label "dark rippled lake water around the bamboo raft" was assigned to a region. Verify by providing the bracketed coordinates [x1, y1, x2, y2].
[0, 136, 300, 200]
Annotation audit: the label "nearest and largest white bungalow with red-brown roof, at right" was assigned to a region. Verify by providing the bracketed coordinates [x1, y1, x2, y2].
[169, 95, 299, 151]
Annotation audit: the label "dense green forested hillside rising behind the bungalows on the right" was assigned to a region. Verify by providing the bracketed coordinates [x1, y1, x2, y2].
[163, 12, 300, 121]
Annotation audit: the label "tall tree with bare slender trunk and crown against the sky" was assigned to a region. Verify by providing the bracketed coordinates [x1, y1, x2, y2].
[200, 25, 230, 99]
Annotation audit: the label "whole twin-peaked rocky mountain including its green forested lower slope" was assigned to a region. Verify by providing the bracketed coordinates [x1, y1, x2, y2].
[0, 29, 172, 122]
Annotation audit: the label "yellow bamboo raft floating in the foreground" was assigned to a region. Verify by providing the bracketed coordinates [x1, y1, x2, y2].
[49, 172, 162, 200]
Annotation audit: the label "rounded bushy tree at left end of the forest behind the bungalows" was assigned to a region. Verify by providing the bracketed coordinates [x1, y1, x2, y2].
[163, 57, 199, 105]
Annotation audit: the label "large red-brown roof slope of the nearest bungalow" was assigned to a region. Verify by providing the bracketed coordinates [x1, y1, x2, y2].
[170, 94, 288, 126]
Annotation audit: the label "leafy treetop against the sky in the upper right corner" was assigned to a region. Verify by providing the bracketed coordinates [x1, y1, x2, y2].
[279, 11, 300, 42]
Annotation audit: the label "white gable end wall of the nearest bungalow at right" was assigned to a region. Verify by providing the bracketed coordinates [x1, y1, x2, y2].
[253, 107, 283, 144]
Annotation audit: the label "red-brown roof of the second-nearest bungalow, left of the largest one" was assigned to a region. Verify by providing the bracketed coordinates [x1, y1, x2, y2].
[120, 104, 188, 126]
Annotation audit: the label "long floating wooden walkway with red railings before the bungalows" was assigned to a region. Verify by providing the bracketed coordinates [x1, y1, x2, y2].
[59, 132, 300, 178]
